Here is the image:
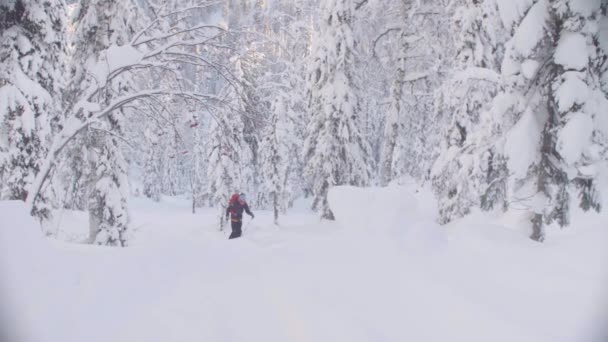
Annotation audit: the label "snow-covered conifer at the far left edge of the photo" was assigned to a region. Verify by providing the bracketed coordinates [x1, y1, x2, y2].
[0, 0, 66, 219]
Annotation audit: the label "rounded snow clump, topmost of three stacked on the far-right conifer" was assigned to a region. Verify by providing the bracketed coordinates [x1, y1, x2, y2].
[554, 33, 589, 70]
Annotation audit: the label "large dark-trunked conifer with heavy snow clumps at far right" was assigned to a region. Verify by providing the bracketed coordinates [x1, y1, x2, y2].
[495, 0, 607, 241]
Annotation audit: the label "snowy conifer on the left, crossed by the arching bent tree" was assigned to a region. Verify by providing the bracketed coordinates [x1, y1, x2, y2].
[67, 0, 141, 246]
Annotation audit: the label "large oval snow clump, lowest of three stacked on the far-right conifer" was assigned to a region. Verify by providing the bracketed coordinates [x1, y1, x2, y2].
[557, 113, 593, 165]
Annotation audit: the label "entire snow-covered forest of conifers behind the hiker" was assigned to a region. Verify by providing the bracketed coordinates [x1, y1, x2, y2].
[0, 0, 608, 246]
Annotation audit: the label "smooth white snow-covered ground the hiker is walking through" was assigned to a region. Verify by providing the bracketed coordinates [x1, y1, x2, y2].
[0, 186, 608, 342]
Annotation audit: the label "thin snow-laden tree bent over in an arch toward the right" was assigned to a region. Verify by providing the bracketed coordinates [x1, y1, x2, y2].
[26, 5, 245, 212]
